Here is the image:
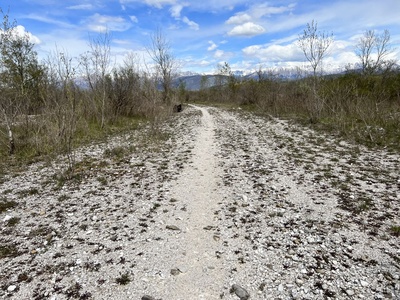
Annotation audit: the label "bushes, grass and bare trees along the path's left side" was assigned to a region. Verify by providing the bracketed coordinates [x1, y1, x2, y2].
[0, 9, 176, 176]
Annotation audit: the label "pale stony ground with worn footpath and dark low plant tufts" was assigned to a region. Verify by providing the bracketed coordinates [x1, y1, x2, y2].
[0, 107, 400, 300]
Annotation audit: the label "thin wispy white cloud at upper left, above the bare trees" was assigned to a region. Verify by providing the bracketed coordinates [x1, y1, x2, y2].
[86, 13, 132, 32]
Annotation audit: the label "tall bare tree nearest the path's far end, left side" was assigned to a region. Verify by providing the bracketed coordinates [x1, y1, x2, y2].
[147, 29, 177, 103]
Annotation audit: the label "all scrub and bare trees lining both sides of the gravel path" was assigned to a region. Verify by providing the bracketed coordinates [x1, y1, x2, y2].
[0, 9, 400, 173]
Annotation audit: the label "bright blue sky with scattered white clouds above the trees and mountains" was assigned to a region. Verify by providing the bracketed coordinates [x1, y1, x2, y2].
[0, 0, 400, 74]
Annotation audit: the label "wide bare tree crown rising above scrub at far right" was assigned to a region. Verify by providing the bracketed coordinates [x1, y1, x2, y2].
[356, 30, 395, 74]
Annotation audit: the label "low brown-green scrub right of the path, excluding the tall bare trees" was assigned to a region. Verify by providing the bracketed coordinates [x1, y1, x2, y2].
[190, 66, 400, 151]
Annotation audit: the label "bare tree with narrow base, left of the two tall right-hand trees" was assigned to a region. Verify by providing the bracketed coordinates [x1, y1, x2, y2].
[298, 20, 333, 77]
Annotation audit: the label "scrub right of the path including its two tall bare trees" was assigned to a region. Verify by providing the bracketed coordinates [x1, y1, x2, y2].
[190, 22, 400, 151]
